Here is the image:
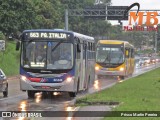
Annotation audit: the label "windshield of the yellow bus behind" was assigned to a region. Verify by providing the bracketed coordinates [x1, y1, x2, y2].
[96, 45, 124, 64]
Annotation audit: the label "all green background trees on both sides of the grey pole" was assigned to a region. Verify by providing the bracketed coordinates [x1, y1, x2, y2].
[0, 0, 154, 48]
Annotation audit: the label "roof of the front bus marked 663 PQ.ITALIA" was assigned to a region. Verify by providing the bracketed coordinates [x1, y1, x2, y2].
[23, 29, 95, 42]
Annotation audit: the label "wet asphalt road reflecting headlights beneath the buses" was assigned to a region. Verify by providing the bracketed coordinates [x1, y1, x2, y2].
[0, 63, 160, 120]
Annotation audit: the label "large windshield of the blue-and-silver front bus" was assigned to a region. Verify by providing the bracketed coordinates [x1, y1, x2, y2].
[21, 40, 73, 70]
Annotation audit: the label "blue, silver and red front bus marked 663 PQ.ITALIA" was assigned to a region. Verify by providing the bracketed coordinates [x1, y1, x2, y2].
[16, 29, 95, 98]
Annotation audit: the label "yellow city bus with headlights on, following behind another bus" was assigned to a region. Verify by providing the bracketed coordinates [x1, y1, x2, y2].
[95, 40, 135, 79]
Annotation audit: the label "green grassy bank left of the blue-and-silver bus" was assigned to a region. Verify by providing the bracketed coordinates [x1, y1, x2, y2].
[0, 41, 19, 76]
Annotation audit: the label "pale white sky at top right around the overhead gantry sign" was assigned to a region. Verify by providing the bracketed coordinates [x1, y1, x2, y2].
[110, 0, 160, 25]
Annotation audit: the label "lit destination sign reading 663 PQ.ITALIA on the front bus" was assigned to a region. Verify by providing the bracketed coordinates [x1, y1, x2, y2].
[28, 32, 67, 39]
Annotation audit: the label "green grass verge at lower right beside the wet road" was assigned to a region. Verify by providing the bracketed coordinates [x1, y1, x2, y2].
[77, 68, 160, 120]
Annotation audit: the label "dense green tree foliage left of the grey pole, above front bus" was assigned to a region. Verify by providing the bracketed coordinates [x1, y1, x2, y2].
[0, 0, 64, 36]
